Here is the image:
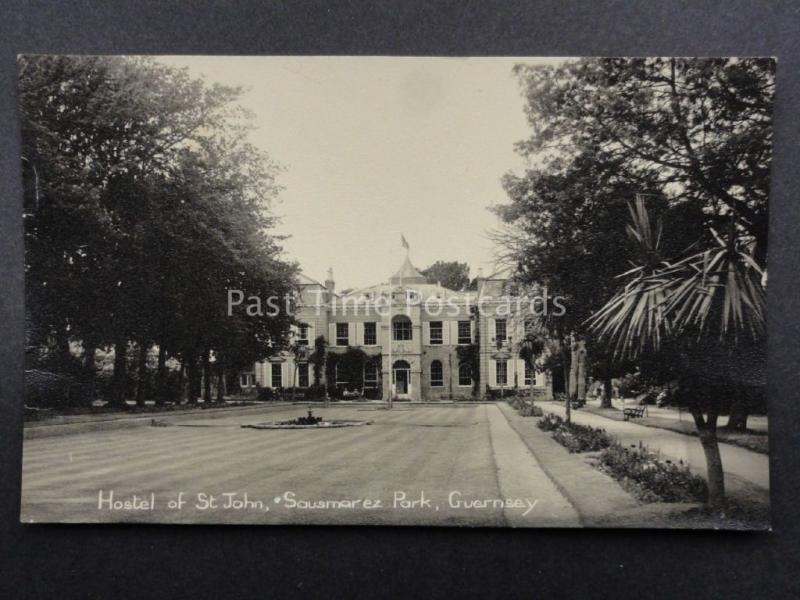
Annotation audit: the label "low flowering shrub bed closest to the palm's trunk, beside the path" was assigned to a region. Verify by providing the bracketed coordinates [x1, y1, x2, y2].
[600, 442, 708, 502]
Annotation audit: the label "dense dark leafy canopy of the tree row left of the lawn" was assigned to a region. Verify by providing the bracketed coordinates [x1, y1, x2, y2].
[19, 56, 295, 406]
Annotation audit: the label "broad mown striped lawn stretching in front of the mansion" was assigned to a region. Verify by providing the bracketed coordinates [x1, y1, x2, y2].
[21, 405, 504, 526]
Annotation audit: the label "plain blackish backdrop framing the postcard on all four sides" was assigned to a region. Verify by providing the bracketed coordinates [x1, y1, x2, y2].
[0, 0, 800, 598]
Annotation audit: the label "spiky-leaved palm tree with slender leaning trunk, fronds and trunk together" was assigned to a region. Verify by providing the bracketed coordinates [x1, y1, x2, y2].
[588, 196, 766, 510]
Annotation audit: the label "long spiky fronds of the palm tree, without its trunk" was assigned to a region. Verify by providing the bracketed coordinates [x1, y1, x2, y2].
[589, 198, 766, 358]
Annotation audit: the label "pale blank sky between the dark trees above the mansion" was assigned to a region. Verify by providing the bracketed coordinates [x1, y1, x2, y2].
[159, 56, 560, 290]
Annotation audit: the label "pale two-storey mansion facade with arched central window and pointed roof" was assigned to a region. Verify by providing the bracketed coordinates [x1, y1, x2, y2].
[247, 257, 552, 401]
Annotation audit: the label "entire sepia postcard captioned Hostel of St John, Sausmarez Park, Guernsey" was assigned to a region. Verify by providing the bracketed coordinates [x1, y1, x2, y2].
[18, 55, 776, 529]
